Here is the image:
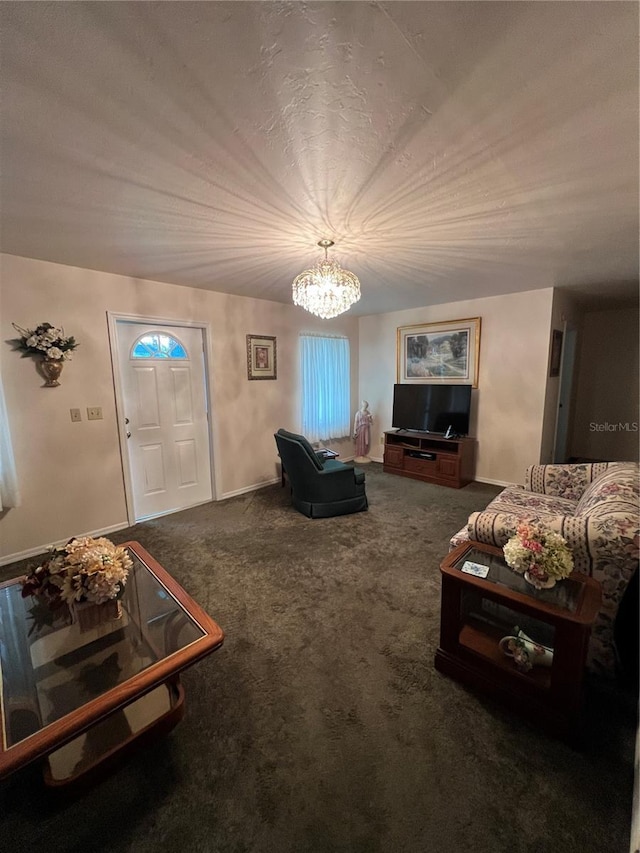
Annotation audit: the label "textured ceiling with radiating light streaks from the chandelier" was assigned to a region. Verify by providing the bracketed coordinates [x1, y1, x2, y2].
[0, 0, 639, 315]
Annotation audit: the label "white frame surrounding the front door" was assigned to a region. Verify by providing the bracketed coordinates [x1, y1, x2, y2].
[107, 311, 220, 525]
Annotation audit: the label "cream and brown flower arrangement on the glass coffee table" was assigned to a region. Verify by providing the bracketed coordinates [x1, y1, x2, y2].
[22, 536, 133, 608]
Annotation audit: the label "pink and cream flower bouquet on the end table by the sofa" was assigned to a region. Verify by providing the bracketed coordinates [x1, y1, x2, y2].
[503, 523, 573, 589]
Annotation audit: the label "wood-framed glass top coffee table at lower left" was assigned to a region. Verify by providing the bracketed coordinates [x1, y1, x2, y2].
[0, 542, 224, 785]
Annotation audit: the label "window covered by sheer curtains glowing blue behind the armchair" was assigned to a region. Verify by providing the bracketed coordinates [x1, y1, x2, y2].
[300, 335, 351, 441]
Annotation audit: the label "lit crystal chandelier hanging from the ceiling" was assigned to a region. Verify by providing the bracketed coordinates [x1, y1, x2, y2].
[293, 240, 360, 320]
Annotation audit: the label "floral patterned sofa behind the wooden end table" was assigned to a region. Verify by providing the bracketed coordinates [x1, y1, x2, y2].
[450, 462, 640, 677]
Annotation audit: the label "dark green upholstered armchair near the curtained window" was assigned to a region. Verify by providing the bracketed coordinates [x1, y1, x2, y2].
[274, 429, 368, 518]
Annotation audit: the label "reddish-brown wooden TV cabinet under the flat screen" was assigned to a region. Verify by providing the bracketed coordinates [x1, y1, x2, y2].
[383, 430, 476, 489]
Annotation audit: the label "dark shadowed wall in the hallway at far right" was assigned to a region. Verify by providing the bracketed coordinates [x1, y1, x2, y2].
[570, 305, 640, 461]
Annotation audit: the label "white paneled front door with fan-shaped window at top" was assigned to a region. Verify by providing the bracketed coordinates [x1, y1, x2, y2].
[116, 320, 212, 521]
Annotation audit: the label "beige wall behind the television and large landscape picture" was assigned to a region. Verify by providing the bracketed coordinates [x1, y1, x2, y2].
[359, 288, 553, 483]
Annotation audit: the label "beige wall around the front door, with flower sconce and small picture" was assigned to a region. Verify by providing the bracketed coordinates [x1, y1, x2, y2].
[0, 255, 358, 562]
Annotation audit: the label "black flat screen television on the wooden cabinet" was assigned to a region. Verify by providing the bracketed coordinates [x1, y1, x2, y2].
[392, 385, 471, 435]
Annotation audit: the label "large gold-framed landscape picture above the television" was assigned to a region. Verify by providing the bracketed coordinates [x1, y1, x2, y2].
[397, 317, 480, 388]
